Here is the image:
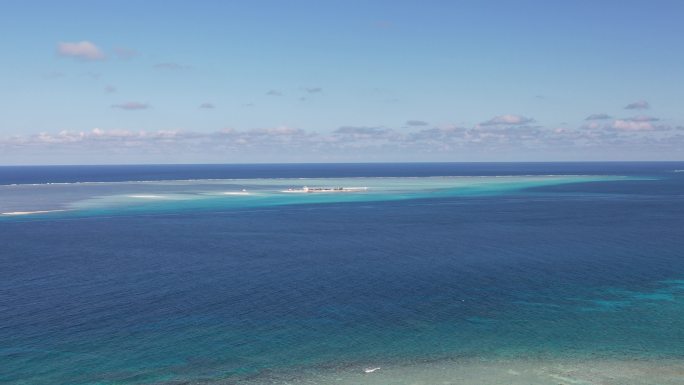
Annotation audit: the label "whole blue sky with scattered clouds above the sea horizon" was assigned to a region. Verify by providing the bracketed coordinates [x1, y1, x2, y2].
[0, 0, 684, 164]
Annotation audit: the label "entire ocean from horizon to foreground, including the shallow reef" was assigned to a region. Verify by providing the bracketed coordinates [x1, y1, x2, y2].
[0, 162, 684, 385]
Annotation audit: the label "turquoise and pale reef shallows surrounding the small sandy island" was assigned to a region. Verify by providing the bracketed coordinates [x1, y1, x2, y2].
[0, 175, 632, 220]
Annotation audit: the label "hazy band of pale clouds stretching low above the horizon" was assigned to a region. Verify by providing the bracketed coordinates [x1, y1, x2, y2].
[0, 115, 684, 161]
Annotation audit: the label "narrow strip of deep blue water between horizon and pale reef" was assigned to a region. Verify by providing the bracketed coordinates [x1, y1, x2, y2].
[0, 162, 682, 185]
